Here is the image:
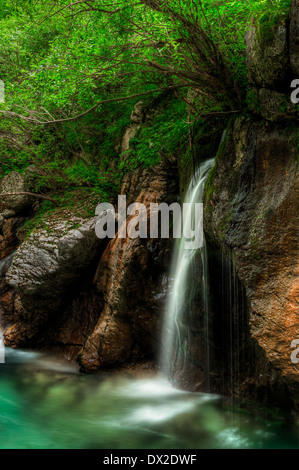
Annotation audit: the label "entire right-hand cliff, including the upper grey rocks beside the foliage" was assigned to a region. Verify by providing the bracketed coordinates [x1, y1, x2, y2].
[205, 5, 299, 412]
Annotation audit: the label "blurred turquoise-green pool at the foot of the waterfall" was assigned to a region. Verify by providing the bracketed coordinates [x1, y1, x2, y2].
[0, 350, 298, 449]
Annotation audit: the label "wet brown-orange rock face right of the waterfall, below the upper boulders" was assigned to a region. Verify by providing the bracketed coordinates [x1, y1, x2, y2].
[205, 119, 299, 408]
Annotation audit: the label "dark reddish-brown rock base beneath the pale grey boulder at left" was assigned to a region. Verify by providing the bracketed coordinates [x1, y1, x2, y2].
[0, 284, 103, 360]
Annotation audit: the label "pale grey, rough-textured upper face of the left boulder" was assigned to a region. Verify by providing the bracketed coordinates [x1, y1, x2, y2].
[6, 218, 100, 297]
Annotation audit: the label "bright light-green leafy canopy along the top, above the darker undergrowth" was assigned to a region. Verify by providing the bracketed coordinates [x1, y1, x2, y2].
[0, 0, 290, 121]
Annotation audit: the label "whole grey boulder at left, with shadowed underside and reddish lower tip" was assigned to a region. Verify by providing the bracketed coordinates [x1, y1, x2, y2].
[5, 218, 103, 346]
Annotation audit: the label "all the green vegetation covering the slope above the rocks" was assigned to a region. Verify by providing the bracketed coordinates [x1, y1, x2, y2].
[0, 0, 290, 217]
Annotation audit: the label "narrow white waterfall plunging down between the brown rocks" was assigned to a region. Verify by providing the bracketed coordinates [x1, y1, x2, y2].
[160, 159, 215, 389]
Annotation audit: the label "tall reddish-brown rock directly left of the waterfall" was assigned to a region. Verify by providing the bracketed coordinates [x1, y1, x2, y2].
[79, 165, 176, 372]
